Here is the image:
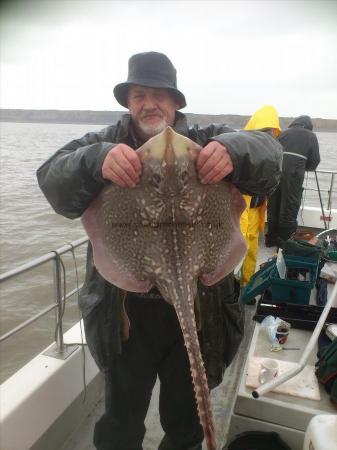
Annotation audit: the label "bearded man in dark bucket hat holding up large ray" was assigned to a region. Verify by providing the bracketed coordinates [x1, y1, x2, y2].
[37, 52, 282, 450]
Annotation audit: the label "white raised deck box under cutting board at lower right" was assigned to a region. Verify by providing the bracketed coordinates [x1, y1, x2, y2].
[228, 323, 337, 450]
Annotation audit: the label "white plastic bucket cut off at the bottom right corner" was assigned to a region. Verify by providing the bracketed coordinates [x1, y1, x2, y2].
[303, 414, 337, 450]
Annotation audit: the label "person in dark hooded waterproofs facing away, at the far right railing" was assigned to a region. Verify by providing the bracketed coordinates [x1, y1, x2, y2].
[265, 116, 320, 247]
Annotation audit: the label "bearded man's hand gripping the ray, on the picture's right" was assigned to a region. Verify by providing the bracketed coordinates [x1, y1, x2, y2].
[197, 141, 233, 184]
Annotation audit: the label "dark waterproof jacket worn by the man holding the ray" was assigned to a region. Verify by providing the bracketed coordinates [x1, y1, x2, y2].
[37, 112, 282, 388]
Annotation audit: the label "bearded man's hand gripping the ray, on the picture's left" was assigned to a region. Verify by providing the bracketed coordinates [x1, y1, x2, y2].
[102, 144, 142, 187]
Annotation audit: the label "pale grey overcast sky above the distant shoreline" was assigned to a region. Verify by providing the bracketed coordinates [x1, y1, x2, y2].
[0, 0, 337, 119]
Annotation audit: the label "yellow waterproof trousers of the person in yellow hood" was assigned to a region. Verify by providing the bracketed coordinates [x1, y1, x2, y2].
[240, 195, 267, 286]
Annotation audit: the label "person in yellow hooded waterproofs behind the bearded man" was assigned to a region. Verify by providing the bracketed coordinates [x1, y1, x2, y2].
[240, 105, 281, 286]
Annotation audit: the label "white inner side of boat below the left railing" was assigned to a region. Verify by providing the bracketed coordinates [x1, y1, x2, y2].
[0, 323, 104, 450]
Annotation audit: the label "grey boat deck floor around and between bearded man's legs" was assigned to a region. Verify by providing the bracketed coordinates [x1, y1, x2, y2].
[59, 244, 276, 450]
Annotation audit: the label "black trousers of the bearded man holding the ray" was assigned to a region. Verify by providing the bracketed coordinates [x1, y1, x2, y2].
[94, 294, 204, 450]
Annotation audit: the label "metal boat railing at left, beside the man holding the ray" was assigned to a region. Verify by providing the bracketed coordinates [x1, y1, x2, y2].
[0, 238, 88, 359]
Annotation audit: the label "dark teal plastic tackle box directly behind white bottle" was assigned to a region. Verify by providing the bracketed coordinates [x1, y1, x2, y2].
[270, 255, 318, 305]
